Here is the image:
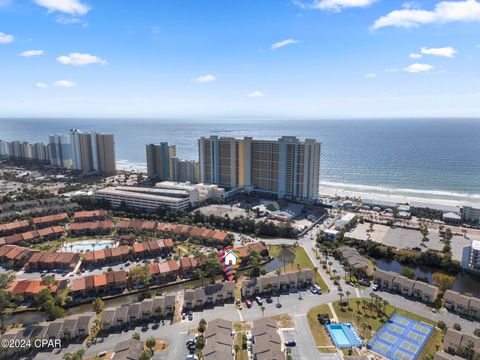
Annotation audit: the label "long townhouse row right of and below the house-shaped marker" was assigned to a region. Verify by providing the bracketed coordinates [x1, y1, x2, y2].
[242, 269, 314, 297]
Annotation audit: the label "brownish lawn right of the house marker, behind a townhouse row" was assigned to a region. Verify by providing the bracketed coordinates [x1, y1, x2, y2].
[268, 245, 329, 293]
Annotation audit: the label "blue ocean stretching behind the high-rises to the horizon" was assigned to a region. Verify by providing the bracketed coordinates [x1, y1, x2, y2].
[0, 119, 480, 202]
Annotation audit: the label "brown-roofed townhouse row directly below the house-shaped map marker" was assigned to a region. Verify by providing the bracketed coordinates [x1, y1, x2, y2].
[183, 281, 235, 310]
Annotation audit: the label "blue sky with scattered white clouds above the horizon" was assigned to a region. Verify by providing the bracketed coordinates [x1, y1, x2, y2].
[0, 0, 480, 118]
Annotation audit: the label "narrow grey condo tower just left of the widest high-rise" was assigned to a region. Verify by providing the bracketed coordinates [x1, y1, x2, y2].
[146, 142, 177, 180]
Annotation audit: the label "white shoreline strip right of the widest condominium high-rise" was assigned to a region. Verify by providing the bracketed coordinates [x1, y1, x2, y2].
[320, 181, 480, 199]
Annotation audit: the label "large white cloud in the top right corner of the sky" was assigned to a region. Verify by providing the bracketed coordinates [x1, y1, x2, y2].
[371, 0, 480, 30]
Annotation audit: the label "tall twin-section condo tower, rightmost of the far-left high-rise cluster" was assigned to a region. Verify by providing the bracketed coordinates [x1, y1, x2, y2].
[70, 129, 115, 174]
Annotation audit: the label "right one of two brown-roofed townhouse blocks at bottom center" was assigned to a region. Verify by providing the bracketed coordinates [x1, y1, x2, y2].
[251, 318, 285, 360]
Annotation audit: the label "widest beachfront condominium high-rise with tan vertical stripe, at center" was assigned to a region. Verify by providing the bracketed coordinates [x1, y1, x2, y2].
[198, 136, 320, 200]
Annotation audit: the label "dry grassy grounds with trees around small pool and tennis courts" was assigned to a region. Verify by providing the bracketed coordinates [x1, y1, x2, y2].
[307, 298, 443, 359]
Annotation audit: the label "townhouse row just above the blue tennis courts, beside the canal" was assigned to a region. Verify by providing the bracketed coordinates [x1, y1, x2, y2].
[374, 269, 440, 304]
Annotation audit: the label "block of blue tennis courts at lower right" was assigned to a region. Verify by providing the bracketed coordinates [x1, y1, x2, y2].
[368, 314, 433, 360]
